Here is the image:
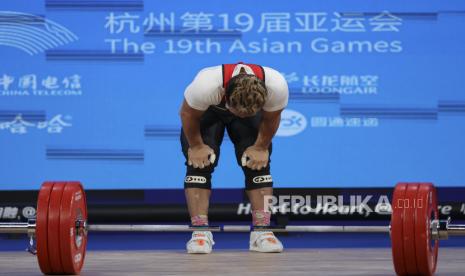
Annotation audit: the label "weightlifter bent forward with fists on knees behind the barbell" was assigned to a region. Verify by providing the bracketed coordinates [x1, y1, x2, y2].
[180, 63, 289, 253]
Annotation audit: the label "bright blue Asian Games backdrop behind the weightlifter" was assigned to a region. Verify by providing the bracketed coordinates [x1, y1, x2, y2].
[0, 0, 465, 190]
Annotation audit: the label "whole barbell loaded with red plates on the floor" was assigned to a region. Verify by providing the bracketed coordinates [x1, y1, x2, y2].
[0, 182, 465, 275]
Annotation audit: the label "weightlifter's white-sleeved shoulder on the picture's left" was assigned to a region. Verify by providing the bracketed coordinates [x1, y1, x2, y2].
[184, 65, 223, 110]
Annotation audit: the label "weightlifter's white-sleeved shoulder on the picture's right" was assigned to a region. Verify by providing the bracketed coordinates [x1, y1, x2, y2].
[263, 67, 289, 112]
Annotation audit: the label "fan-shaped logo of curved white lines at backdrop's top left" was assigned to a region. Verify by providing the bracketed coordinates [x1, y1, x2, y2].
[0, 11, 78, 56]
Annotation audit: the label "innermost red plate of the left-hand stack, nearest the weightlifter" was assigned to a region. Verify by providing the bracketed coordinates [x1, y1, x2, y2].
[60, 182, 87, 274]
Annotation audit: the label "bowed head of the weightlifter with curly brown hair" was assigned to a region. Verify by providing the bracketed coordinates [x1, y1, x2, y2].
[225, 70, 267, 117]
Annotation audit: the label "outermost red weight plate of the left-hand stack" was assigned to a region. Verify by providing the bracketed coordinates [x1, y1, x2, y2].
[36, 182, 53, 274]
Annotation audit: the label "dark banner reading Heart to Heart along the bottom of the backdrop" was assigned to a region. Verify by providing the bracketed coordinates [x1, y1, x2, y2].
[0, 187, 465, 223]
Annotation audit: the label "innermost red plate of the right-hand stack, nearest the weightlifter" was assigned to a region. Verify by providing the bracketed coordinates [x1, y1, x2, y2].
[391, 183, 407, 275]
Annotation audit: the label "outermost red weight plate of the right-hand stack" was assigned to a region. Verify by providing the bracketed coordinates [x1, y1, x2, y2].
[415, 183, 439, 275]
